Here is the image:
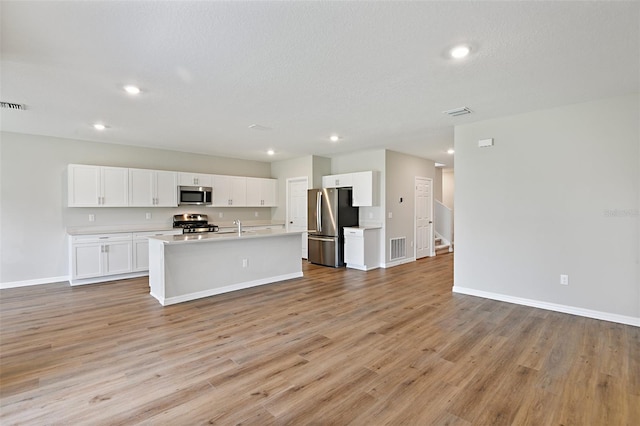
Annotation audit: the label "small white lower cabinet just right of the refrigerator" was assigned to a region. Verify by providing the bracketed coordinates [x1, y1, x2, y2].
[344, 227, 380, 271]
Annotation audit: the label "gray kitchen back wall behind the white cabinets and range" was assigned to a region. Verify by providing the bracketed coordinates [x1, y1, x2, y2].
[0, 132, 271, 283]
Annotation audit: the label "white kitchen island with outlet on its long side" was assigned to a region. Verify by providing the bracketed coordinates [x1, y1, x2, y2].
[149, 230, 302, 306]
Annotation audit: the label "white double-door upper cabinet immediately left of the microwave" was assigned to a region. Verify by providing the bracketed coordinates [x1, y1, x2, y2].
[129, 169, 178, 207]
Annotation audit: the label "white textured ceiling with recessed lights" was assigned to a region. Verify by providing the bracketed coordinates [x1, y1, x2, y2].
[0, 1, 640, 167]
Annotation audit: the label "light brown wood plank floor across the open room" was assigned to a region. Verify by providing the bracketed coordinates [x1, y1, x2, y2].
[0, 255, 640, 426]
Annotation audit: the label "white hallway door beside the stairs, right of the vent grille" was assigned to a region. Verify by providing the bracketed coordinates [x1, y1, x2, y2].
[415, 177, 433, 259]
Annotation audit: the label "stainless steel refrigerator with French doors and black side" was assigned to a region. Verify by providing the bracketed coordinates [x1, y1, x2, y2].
[307, 188, 358, 267]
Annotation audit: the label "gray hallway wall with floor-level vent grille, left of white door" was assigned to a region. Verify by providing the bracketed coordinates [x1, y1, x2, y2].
[385, 151, 435, 262]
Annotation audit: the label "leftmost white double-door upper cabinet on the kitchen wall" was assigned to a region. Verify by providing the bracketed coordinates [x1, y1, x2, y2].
[67, 164, 129, 207]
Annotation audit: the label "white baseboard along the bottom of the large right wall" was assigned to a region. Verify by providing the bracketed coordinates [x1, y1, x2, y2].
[453, 286, 640, 327]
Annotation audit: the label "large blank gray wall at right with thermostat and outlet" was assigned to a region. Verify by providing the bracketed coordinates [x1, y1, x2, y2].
[454, 94, 640, 318]
